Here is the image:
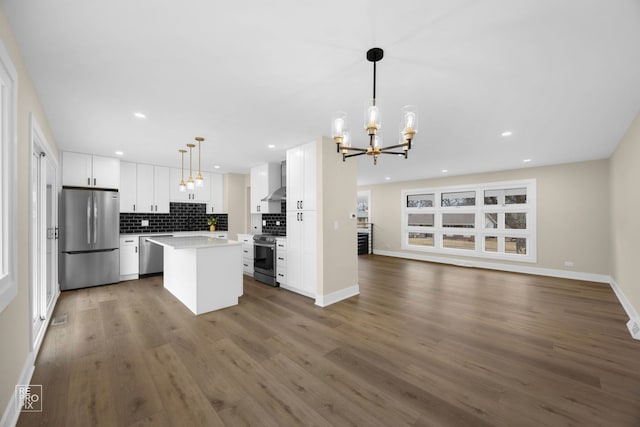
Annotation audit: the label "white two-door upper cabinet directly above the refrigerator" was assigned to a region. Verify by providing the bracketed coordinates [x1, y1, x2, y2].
[62, 151, 120, 189]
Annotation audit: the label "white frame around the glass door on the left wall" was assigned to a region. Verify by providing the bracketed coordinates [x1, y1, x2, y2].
[29, 113, 60, 354]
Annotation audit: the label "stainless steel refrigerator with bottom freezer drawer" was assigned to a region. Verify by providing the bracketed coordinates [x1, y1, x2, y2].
[59, 188, 120, 290]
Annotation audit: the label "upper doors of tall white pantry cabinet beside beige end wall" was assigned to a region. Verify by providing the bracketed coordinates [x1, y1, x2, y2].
[287, 141, 317, 211]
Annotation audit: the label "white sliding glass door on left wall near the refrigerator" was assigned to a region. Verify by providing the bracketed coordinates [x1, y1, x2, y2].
[29, 115, 60, 354]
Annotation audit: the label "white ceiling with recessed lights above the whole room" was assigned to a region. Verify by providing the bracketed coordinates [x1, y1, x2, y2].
[0, 0, 640, 184]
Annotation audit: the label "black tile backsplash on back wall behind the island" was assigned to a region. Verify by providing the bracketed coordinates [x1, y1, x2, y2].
[120, 203, 229, 234]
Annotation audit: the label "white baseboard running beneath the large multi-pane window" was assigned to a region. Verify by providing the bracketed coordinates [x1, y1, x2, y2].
[373, 250, 611, 283]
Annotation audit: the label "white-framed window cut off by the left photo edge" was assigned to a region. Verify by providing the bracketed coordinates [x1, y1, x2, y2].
[0, 41, 18, 312]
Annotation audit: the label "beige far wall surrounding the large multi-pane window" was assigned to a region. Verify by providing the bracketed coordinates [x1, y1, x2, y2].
[358, 158, 611, 275]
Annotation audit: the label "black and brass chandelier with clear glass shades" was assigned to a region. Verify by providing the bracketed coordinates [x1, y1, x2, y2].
[331, 47, 418, 165]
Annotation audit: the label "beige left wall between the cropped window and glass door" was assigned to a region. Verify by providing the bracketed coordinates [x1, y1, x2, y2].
[0, 8, 57, 417]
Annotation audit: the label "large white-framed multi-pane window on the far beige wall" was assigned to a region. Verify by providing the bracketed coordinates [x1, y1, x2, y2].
[402, 180, 536, 262]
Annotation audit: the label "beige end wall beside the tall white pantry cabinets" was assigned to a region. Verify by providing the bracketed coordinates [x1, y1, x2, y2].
[316, 138, 358, 296]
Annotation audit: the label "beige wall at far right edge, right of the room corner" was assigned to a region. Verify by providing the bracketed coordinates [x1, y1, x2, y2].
[610, 114, 640, 320]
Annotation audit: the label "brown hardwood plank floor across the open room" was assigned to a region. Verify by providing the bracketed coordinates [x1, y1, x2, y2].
[18, 255, 640, 427]
